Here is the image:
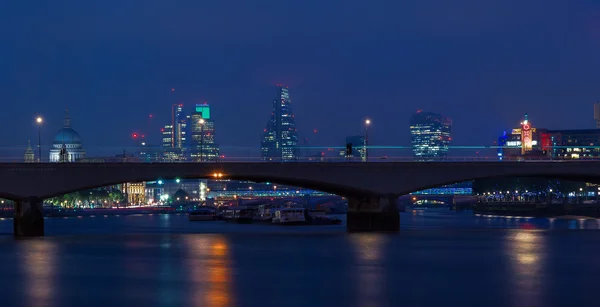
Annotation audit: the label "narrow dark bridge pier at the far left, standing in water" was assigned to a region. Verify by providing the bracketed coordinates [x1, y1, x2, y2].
[13, 197, 44, 238]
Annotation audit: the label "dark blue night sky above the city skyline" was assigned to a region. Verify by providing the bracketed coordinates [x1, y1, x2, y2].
[0, 0, 600, 158]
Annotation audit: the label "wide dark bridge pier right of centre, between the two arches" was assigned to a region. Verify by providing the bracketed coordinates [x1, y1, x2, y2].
[346, 195, 400, 232]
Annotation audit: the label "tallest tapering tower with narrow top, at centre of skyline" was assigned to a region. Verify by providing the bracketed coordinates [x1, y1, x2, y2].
[261, 85, 298, 161]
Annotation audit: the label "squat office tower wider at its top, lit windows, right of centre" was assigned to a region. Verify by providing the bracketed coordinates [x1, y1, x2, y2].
[410, 111, 452, 161]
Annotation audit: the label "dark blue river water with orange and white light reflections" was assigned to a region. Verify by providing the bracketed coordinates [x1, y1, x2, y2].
[0, 211, 600, 307]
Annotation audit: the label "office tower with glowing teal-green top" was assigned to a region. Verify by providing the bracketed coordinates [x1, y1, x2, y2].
[188, 103, 219, 162]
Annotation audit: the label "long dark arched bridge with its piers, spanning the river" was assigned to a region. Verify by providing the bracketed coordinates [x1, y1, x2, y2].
[0, 160, 600, 237]
